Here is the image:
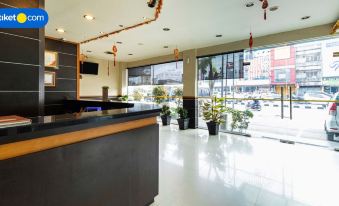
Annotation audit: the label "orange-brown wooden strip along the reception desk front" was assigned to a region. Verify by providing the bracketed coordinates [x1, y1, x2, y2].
[0, 117, 157, 160]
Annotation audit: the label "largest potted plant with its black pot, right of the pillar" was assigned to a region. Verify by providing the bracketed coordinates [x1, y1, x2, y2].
[202, 97, 226, 135]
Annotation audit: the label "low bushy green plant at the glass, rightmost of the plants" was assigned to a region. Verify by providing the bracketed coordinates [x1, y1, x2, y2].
[227, 108, 253, 131]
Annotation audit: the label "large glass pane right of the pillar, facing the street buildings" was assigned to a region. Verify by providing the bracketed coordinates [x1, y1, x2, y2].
[198, 35, 339, 144]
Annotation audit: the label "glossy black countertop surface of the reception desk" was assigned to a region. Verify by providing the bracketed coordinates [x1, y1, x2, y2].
[0, 100, 161, 145]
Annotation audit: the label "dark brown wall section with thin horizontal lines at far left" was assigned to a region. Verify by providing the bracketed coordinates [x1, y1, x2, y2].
[0, 0, 45, 116]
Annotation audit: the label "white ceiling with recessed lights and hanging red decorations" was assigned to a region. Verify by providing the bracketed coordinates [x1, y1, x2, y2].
[46, 0, 339, 62]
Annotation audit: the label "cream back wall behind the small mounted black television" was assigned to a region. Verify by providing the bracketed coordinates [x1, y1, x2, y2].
[80, 58, 122, 97]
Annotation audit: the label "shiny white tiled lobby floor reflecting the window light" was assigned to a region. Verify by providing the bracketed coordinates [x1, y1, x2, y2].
[152, 125, 339, 206]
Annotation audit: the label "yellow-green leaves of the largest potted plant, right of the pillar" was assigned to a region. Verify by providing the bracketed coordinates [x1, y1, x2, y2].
[202, 96, 226, 124]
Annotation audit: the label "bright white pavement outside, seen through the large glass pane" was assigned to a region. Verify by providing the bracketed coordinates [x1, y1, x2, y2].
[199, 102, 327, 141]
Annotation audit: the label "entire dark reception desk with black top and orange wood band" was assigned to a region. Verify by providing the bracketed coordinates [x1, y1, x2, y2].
[0, 102, 160, 206]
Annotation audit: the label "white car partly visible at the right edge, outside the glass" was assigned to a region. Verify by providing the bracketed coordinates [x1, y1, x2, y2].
[325, 93, 339, 141]
